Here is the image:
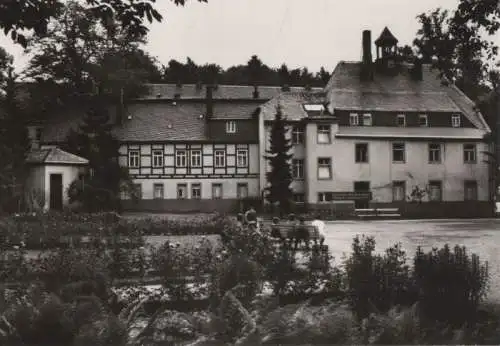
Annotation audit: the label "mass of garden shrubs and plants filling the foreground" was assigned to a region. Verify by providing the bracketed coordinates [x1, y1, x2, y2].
[0, 219, 500, 345]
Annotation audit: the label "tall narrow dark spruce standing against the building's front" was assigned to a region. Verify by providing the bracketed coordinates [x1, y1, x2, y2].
[266, 105, 292, 213]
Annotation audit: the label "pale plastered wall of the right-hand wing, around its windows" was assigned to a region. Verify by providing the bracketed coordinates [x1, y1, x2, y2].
[300, 124, 488, 203]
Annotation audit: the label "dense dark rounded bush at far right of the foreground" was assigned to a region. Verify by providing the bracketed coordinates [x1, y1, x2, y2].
[414, 244, 489, 326]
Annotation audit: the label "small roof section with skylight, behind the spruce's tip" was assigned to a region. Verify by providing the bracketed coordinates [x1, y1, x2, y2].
[261, 92, 325, 121]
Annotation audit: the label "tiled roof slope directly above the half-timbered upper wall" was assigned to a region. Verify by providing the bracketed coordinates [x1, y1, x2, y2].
[113, 103, 208, 142]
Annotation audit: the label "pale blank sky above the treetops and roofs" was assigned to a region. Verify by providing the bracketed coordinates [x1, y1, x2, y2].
[0, 0, 500, 71]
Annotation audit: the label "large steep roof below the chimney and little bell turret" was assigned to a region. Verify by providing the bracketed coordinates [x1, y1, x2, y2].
[325, 62, 490, 131]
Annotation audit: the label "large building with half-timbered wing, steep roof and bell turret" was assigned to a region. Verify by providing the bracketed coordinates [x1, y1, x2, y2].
[32, 28, 491, 216]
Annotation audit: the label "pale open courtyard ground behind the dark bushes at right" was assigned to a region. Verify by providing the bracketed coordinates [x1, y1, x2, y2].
[325, 219, 500, 302]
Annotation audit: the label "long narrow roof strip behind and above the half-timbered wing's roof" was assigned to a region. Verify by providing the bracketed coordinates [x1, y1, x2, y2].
[140, 84, 322, 101]
